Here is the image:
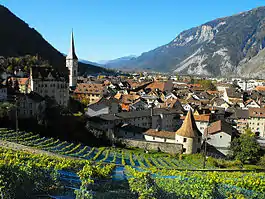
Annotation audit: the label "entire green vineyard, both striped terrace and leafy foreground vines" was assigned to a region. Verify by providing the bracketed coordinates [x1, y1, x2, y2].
[0, 129, 265, 199]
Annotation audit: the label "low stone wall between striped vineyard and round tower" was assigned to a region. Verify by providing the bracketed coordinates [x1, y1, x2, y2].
[120, 139, 182, 155]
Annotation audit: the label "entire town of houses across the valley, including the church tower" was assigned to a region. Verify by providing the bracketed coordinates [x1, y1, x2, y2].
[0, 31, 265, 155]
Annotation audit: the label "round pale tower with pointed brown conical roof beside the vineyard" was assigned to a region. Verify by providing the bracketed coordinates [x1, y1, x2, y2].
[175, 110, 202, 154]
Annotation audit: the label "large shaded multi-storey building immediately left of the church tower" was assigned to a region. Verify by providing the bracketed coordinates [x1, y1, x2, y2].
[30, 67, 69, 106]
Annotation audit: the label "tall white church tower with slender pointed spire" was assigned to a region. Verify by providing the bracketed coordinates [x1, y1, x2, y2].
[66, 31, 78, 87]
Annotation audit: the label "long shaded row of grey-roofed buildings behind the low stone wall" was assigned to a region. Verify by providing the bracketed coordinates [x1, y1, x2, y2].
[87, 108, 182, 139]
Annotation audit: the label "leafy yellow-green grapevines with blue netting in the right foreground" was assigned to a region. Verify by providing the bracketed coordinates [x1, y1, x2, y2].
[126, 166, 265, 199]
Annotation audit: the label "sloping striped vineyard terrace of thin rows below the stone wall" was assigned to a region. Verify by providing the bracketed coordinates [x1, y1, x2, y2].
[0, 130, 213, 169]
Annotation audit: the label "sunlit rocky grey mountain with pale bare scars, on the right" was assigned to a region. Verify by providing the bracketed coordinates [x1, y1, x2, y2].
[112, 7, 265, 76]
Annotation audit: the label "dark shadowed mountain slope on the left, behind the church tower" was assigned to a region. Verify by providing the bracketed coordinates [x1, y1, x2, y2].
[0, 5, 107, 74]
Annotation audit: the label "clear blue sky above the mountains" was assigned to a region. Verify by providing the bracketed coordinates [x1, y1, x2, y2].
[0, 0, 265, 61]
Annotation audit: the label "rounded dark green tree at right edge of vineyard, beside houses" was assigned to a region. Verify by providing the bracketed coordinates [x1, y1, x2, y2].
[230, 129, 261, 163]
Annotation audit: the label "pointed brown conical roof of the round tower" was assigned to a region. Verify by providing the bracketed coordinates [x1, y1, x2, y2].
[176, 110, 202, 138]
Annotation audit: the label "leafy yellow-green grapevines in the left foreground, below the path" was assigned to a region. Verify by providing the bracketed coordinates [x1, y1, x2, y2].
[0, 147, 115, 199]
